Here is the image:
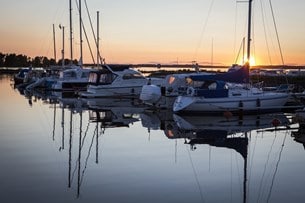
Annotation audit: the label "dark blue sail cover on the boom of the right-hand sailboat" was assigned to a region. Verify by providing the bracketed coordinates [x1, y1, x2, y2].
[189, 65, 249, 83]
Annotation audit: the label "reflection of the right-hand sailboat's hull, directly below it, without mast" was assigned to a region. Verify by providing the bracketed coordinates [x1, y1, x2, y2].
[141, 111, 291, 139]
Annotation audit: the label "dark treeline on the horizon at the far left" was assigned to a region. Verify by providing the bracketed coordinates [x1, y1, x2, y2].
[0, 52, 77, 67]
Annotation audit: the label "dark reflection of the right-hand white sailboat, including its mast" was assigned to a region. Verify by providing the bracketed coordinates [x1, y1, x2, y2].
[142, 112, 291, 202]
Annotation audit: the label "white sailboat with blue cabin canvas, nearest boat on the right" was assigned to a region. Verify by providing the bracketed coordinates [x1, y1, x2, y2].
[173, 0, 289, 113]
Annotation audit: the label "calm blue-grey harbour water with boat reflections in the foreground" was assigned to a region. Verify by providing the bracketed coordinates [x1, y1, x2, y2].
[0, 75, 305, 203]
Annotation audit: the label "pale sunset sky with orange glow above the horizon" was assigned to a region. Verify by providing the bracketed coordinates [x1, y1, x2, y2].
[0, 0, 305, 65]
